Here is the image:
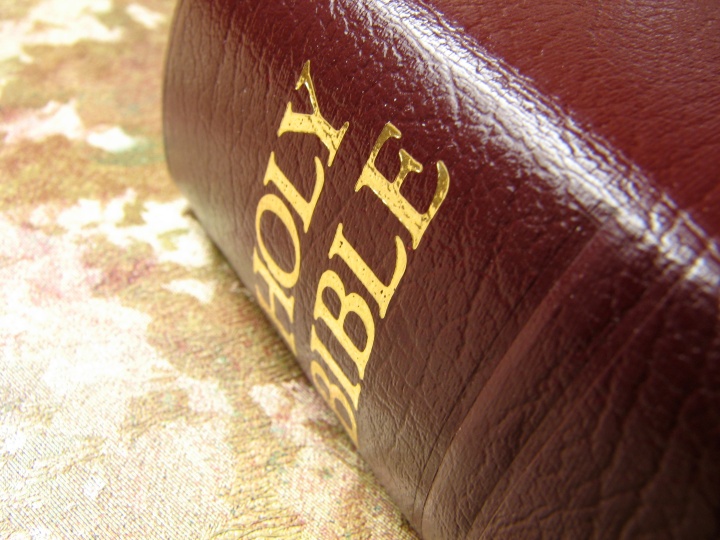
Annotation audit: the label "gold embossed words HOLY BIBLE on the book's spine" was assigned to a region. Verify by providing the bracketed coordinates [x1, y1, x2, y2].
[253, 60, 450, 445]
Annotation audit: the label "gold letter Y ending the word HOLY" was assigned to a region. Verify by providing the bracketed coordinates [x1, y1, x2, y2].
[278, 60, 350, 167]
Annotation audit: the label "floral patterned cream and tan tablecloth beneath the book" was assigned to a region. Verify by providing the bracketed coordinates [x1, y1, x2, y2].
[0, 0, 420, 539]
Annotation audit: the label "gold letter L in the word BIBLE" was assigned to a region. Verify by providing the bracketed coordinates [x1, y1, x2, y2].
[328, 223, 407, 318]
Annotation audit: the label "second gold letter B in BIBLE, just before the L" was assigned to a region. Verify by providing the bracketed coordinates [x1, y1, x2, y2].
[313, 270, 375, 379]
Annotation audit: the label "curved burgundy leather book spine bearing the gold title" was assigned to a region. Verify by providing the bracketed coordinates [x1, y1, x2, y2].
[165, 0, 720, 538]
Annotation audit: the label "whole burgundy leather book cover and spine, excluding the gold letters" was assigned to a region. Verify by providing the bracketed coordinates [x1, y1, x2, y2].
[164, 0, 720, 539]
